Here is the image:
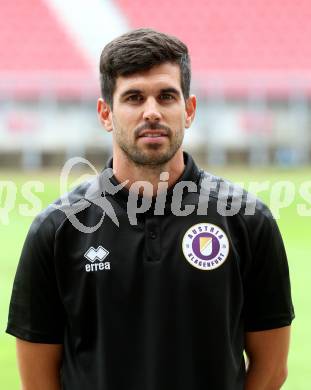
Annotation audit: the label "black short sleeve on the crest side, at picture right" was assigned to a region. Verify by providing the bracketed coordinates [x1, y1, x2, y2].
[244, 205, 295, 331]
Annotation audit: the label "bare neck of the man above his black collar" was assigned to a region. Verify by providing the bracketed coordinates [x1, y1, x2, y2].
[113, 149, 185, 196]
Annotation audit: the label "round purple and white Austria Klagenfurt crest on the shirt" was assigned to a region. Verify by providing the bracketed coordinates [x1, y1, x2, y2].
[182, 223, 229, 271]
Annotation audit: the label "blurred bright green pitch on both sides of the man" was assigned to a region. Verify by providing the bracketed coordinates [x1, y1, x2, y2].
[0, 168, 311, 390]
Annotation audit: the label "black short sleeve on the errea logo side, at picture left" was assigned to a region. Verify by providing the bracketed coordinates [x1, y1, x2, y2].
[6, 215, 64, 343]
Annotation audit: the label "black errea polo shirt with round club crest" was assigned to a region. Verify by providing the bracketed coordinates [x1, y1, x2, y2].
[7, 154, 294, 390]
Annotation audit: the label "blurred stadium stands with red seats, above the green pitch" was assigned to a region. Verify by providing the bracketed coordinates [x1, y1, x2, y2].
[0, 0, 311, 169]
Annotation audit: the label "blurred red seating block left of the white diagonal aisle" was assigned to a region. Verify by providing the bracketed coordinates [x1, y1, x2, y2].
[0, 0, 96, 95]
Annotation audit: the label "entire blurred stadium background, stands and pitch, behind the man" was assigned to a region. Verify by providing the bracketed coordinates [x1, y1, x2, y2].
[0, 0, 311, 390]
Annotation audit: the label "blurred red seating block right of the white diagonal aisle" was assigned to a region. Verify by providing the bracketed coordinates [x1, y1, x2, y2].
[115, 0, 311, 96]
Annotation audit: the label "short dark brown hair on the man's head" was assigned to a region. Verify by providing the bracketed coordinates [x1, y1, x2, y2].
[99, 28, 191, 107]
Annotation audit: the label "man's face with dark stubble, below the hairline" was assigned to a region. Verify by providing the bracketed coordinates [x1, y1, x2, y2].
[100, 63, 194, 166]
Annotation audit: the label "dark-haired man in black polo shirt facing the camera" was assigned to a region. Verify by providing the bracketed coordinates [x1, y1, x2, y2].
[7, 29, 294, 390]
